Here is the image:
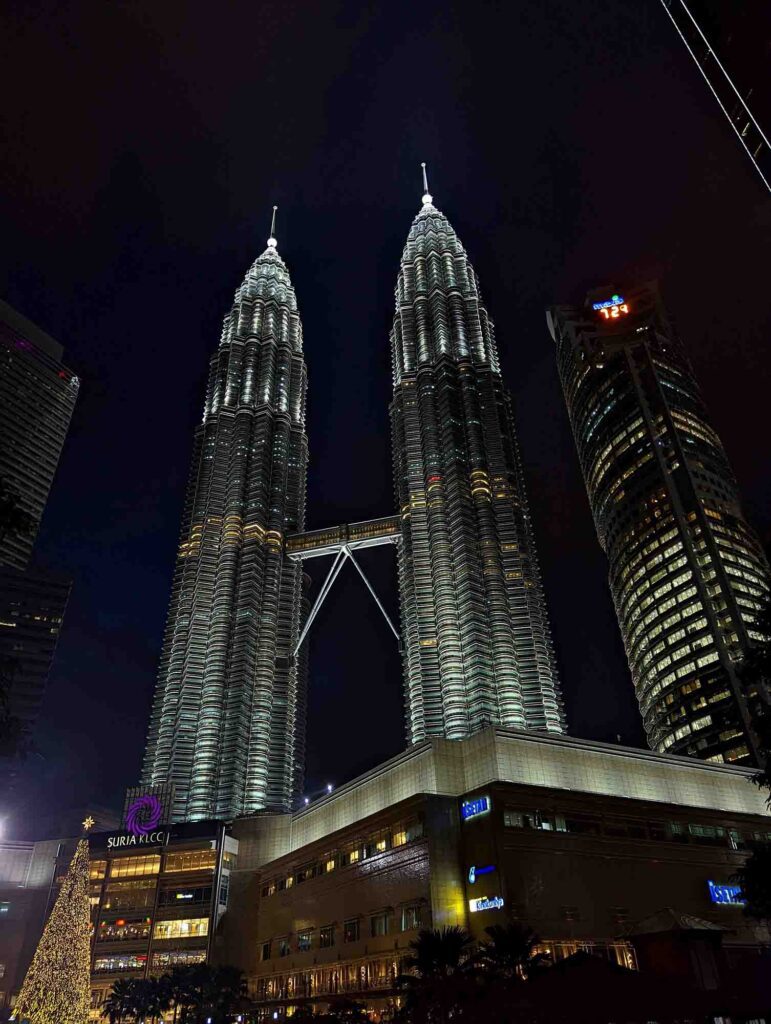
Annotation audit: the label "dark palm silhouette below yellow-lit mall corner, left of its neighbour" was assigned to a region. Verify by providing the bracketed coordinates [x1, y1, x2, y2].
[396, 926, 475, 1024]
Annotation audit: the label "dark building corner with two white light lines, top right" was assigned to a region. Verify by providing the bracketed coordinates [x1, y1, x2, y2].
[661, 0, 771, 191]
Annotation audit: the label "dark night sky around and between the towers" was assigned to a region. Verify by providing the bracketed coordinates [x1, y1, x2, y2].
[0, 0, 771, 834]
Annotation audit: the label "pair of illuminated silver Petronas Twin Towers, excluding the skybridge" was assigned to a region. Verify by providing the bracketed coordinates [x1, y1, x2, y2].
[142, 174, 564, 820]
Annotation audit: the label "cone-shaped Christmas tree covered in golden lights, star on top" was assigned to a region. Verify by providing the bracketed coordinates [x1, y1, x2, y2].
[13, 819, 91, 1024]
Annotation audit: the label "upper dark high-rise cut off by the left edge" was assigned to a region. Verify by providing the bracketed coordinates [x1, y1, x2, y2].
[0, 302, 79, 569]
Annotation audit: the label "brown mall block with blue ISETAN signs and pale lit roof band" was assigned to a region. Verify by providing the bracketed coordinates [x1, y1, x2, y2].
[219, 728, 771, 1020]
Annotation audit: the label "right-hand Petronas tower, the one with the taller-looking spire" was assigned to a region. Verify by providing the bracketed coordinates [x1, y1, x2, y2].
[391, 184, 565, 742]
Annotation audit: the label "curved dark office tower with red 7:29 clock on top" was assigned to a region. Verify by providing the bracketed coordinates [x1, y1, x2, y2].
[547, 283, 769, 763]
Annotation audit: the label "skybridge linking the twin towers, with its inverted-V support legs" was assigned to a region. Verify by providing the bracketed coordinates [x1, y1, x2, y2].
[285, 516, 401, 655]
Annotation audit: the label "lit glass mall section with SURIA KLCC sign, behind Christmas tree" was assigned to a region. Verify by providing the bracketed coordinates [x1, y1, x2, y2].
[0, 821, 238, 1020]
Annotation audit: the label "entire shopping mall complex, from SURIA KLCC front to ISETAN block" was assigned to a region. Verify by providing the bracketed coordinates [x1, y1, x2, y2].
[0, 728, 771, 1020]
